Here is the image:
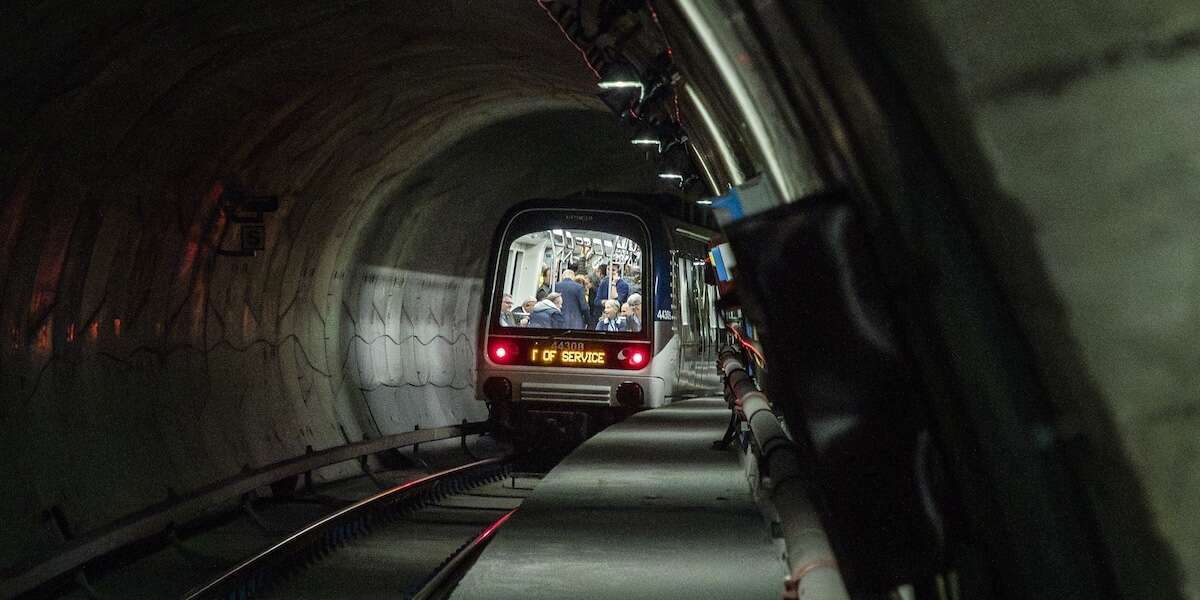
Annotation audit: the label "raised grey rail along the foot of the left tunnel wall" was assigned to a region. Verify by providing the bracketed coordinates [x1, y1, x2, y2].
[0, 421, 488, 598]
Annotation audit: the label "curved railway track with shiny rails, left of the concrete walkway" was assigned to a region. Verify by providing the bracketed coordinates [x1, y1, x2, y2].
[184, 457, 541, 600]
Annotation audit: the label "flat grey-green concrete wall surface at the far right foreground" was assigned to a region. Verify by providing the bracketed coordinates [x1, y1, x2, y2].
[878, 0, 1200, 599]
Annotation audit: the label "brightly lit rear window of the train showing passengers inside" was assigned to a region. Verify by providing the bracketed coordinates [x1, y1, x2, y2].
[496, 229, 646, 336]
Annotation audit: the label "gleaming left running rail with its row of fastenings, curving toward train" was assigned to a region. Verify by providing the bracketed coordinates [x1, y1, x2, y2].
[184, 456, 512, 600]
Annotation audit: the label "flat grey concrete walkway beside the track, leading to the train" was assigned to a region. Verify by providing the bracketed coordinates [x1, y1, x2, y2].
[454, 398, 786, 600]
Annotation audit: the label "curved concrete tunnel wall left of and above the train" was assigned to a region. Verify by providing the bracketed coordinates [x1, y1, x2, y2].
[0, 1, 654, 574]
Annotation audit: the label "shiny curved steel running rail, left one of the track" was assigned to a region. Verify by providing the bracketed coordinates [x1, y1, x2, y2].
[184, 456, 511, 600]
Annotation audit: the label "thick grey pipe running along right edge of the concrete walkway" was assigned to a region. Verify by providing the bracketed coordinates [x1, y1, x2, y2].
[718, 350, 850, 600]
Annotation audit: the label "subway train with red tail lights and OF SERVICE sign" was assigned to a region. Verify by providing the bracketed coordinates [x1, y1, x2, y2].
[476, 193, 720, 439]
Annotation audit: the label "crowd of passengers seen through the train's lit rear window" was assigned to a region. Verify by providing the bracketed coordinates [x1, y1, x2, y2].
[500, 264, 642, 331]
